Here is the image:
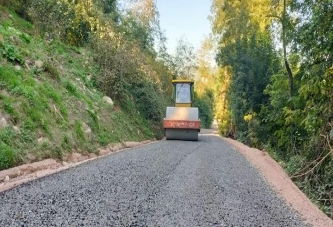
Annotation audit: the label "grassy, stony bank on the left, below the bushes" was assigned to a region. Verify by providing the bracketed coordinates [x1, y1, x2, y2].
[0, 7, 154, 170]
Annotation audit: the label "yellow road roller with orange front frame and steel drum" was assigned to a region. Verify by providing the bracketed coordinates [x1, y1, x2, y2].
[163, 80, 200, 141]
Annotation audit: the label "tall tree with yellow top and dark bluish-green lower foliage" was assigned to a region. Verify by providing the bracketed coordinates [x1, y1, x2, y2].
[212, 0, 276, 139]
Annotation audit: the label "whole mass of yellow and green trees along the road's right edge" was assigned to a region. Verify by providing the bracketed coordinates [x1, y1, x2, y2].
[212, 0, 333, 217]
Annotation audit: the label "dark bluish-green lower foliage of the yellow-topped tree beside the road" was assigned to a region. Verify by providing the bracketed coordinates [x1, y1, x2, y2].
[218, 32, 278, 143]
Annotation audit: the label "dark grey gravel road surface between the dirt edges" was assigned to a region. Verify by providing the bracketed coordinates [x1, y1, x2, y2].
[0, 135, 305, 226]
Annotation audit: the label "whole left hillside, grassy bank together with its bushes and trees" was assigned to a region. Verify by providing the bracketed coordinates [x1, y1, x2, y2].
[0, 0, 172, 170]
